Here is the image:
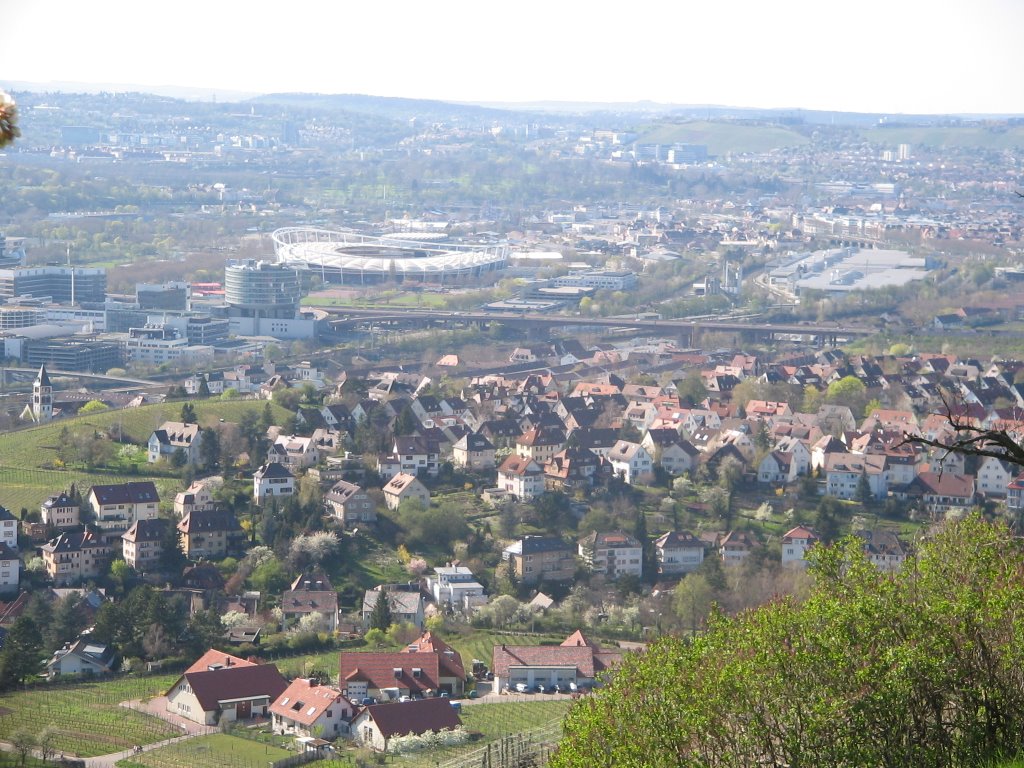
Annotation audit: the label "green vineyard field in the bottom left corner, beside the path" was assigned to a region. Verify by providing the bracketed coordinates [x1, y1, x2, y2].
[0, 675, 181, 757]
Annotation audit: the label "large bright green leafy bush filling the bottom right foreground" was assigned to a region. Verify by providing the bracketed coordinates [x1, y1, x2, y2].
[549, 517, 1024, 768]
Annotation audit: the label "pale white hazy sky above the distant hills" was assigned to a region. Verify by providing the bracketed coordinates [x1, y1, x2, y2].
[0, 0, 1024, 114]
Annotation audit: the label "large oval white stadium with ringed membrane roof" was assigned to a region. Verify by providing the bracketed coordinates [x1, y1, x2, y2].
[271, 226, 509, 286]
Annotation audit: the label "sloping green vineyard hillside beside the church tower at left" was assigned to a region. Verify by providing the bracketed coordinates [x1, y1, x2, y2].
[0, 399, 291, 512]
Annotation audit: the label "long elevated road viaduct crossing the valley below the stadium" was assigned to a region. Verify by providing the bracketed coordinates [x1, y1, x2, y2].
[310, 306, 878, 341]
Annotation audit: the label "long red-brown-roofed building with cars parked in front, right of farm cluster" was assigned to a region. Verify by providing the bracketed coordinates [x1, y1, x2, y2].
[490, 631, 622, 690]
